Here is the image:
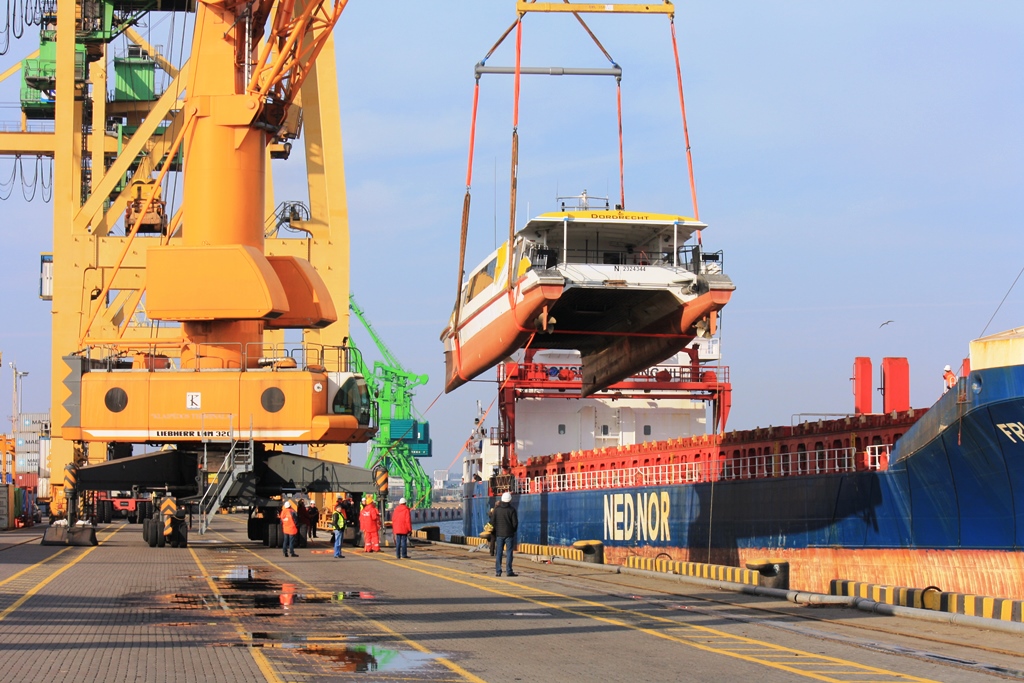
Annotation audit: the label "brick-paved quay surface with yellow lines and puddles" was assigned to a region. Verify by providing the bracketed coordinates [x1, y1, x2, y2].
[0, 514, 1024, 683]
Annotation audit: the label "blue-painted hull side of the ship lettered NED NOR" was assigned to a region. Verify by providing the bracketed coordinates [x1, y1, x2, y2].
[464, 366, 1024, 591]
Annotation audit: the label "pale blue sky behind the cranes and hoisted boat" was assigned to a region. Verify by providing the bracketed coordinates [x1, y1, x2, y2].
[0, 0, 1024, 481]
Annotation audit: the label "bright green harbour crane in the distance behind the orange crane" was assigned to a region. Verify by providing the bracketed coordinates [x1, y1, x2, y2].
[348, 295, 431, 508]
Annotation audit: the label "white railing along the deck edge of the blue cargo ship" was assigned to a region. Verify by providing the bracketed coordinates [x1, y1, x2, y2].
[514, 444, 892, 494]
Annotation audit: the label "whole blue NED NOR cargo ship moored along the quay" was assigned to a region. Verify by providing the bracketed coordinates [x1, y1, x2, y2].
[464, 328, 1024, 599]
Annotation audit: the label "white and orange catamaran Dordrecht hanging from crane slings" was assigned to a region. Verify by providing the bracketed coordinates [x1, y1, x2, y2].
[441, 191, 735, 395]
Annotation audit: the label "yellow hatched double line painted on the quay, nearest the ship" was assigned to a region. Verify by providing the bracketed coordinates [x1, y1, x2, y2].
[370, 553, 936, 683]
